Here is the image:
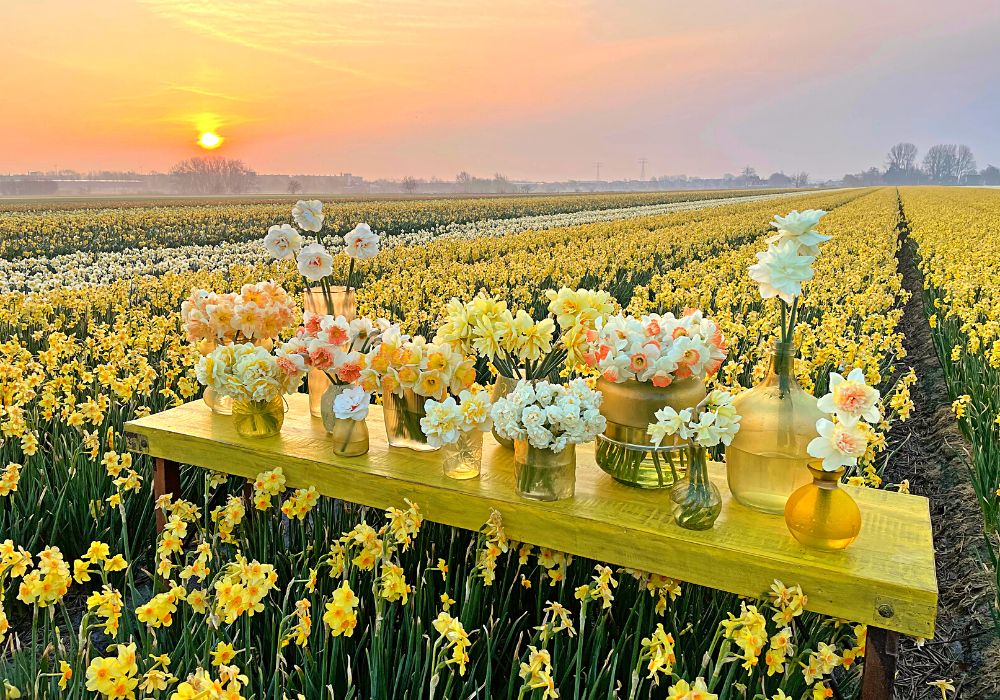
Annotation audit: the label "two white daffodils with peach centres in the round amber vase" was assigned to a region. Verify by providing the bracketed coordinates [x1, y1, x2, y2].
[806, 368, 882, 471]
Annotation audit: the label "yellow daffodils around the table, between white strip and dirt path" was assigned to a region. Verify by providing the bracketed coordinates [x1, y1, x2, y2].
[0, 191, 892, 699]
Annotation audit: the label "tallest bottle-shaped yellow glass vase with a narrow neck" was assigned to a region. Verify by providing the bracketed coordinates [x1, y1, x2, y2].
[726, 342, 826, 515]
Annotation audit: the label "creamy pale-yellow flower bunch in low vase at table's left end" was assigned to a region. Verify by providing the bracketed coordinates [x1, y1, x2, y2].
[196, 343, 306, 403]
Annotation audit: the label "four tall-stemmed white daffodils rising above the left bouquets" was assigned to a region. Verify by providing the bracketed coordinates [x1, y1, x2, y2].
[264, 199, 379, 313]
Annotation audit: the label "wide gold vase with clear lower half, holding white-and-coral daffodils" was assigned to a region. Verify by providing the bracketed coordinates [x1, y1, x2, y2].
[594, 378, 708, 489]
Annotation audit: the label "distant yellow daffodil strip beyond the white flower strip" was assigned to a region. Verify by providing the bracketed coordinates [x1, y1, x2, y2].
[0, 190, 796, 259]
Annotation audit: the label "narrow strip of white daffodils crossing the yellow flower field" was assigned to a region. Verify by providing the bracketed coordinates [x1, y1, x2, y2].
[0, 189, 820, 292]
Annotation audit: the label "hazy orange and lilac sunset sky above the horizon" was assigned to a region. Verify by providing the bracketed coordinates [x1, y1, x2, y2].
[0, 0, 1000, 180]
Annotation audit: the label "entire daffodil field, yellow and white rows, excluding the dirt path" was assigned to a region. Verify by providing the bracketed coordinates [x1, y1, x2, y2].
[0, 188, 984, 700]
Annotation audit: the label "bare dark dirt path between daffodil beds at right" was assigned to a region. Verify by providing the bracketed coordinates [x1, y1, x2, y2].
[886, 216, 1000, 700]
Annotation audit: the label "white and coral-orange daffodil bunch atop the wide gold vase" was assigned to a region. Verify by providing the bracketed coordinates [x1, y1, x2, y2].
[583, 311, 727, 387]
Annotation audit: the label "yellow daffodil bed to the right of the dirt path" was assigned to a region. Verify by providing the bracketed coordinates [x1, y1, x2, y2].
[902, 188, 1000, 624]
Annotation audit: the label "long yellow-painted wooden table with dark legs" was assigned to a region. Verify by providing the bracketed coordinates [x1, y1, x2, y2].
[125, 394, 937, 698]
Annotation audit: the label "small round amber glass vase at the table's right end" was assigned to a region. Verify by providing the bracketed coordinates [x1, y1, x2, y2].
[785, 461, 861, 551]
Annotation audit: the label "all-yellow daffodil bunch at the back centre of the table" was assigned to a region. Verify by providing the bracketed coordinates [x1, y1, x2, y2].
[434, 287, 614, 380]
